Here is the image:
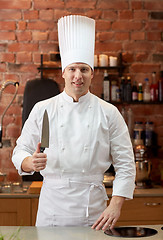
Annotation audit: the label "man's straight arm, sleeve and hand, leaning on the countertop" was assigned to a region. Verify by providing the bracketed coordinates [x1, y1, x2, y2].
[92, 104, 135, 231]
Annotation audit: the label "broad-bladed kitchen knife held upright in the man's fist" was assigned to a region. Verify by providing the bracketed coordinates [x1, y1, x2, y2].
[40, 110, 49, 152]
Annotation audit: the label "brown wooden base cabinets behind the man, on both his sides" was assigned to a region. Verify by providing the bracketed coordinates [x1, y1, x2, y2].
[0, 186, 163, 226]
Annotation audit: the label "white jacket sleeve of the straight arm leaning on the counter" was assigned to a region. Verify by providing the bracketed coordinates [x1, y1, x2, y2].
[109, 108, 136, 199]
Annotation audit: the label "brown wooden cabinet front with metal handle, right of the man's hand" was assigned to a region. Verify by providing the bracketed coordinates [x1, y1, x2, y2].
[107, 197, 163, 226]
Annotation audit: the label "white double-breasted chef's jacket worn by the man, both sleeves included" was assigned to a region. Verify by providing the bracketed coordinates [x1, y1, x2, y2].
[12, 91, 135, 226]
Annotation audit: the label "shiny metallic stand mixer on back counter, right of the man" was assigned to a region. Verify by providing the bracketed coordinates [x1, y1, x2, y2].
[134, 145, 152, 188]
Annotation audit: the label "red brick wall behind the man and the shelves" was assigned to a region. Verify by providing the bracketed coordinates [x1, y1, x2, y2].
[0, 0, 163, 183]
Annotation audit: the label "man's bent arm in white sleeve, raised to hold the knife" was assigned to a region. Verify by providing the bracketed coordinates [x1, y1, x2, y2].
[12, 103, 45, 176]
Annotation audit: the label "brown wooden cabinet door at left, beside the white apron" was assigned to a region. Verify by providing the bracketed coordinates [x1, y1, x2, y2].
[0, 198, 31, 226]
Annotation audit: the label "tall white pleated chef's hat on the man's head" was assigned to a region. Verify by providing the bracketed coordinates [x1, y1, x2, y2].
[58, 15, 95, 71]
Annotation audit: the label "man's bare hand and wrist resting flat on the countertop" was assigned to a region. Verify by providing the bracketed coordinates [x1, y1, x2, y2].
[92, 196, 125, 231]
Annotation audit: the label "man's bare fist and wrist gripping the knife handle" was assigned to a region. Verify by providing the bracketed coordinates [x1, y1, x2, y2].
[21, 143, 47, 173]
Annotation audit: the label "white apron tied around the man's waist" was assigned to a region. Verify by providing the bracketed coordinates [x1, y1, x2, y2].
[36, 173, 108, 226]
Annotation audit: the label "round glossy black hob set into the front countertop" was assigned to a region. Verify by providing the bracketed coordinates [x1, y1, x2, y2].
[104, 227, 157, 238]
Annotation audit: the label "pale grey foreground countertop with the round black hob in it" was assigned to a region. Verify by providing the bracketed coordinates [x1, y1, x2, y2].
[0, 225, 163, 240]
